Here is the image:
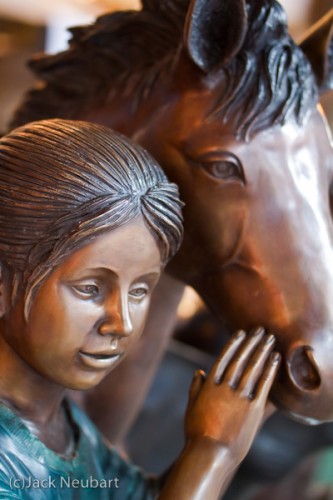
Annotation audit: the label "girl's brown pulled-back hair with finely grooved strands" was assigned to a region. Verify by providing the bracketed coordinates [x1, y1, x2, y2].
[0, 119, 183, 314]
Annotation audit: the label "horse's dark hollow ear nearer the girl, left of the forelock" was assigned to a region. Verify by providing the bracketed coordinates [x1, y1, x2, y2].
[184, 0, 247, 73]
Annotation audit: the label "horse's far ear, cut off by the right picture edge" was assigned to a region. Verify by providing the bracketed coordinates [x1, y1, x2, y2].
[299, 9, 333, 92]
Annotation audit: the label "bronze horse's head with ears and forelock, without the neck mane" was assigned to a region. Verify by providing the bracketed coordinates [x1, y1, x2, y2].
[135, 0, 333, 423]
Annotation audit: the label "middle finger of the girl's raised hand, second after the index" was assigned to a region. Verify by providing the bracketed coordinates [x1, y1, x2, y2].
[223, 328, 265, 388]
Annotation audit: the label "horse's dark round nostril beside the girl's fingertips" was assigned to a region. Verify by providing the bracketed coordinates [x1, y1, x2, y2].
[288, 346, 321, 391]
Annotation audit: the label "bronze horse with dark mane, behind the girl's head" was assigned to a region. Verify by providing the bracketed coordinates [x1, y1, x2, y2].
[12, 0, 333, 430]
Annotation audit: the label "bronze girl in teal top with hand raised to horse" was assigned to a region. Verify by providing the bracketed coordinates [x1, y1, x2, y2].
[0, 120, 280, 500]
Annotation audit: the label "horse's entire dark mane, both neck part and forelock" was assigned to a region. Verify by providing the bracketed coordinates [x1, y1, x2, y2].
[11, 0, 317, 136]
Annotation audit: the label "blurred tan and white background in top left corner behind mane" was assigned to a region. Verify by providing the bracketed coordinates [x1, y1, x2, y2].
[0, 0, 140, 132]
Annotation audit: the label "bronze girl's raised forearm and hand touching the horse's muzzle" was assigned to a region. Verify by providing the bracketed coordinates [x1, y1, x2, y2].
[159, 328, 280, 500]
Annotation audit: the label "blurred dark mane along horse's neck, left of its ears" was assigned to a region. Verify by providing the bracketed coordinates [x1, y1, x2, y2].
[11, 0, 189, 126]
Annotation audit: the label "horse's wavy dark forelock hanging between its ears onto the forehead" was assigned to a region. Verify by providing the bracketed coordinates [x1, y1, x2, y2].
[212, 0, 318, 138]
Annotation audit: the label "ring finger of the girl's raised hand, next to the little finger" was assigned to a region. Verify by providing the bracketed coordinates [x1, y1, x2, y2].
[239, 335, 275, 397]
